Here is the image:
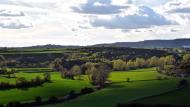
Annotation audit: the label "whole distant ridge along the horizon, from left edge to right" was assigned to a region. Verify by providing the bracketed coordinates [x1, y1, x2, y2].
[0, 38, 190, 49]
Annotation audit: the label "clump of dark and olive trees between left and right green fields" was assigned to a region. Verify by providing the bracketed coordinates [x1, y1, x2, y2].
[53, 59, 109, 86]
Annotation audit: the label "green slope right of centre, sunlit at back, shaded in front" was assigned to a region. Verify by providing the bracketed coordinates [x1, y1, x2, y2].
[44, 69, 189, 107]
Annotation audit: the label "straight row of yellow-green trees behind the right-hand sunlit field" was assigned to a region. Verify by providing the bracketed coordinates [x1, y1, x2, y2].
[112, 55, 176, 70]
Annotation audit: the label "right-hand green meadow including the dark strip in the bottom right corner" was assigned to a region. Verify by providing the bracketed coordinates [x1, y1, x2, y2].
[44, 68, 190, 107]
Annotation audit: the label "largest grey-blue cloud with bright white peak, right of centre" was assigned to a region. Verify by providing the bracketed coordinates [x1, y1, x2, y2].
[91, 5, 174, 30]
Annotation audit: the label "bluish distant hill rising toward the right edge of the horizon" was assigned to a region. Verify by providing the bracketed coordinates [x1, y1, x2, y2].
[93, 39, 190, 48]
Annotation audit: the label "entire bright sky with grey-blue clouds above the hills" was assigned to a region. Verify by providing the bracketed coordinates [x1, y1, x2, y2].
[0, 0, 190, 47]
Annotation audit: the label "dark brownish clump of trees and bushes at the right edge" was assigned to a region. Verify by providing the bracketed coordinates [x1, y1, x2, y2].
[157, 54, 190, 77]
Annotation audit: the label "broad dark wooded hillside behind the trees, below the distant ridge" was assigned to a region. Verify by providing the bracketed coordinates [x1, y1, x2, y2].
[0, 47, 168, 68]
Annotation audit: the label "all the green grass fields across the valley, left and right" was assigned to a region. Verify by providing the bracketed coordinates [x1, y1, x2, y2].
[0, 68, 190, 107]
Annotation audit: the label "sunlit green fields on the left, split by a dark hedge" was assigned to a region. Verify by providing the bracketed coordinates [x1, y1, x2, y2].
[0, 73, 90, 104]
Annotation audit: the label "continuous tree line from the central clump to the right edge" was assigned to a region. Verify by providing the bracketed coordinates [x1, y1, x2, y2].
[52, 54, 190, 86]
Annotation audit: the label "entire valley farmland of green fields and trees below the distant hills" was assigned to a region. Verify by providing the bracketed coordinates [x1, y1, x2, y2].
[0, 47, 190, 107]
